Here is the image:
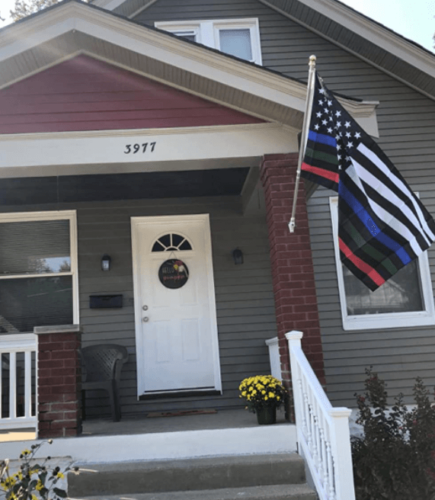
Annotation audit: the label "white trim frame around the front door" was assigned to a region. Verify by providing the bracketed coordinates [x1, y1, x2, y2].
[131, 214, 222, 398]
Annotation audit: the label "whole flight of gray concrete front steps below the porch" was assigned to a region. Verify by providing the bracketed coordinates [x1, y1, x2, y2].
[68, 453, 317, 500]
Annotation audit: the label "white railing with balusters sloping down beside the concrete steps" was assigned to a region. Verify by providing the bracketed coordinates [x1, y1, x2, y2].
[286, 331, 355, 500]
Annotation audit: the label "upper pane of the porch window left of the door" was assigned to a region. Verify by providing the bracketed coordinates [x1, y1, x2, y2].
[0, 220, 71, 275]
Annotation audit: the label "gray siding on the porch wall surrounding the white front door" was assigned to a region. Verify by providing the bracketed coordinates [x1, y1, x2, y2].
[2, 196, 277, 417]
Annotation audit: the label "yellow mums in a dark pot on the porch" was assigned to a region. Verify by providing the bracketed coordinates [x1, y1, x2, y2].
[239, 375, 287, 425]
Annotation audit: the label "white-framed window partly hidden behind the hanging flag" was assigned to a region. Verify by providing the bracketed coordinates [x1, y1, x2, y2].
[330, 197, 435, 330]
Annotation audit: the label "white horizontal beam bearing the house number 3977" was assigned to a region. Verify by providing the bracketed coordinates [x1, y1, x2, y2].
[0, 123, 298, 178]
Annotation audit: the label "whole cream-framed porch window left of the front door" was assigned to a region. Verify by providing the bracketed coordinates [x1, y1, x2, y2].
[0, 211, 79, 333]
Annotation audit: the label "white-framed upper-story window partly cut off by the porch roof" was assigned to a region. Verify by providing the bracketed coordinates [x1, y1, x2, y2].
[156, 19, 262, 64]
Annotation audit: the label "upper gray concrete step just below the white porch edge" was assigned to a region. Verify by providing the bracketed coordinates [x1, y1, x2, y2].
[68, 453, 305, 498]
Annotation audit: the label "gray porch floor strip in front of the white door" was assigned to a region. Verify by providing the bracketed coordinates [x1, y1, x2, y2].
[82, 409, 290, 436]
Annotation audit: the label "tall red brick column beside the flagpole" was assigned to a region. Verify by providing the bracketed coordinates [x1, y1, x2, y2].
[261, 154, 325, 388]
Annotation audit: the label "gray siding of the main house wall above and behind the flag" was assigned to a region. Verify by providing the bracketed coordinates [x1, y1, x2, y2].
[136, 0, 435, 406]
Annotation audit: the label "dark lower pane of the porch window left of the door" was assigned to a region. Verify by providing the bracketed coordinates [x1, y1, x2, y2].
[0, 276, 73, 333]
